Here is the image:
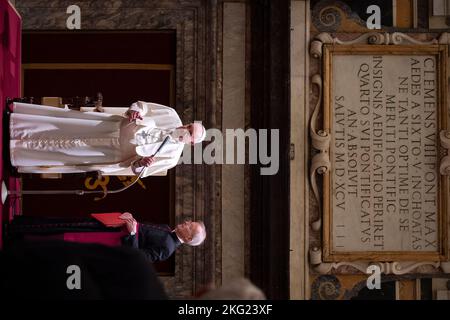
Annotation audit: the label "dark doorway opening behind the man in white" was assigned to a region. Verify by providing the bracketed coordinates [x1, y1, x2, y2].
[22, 31, 176, 274]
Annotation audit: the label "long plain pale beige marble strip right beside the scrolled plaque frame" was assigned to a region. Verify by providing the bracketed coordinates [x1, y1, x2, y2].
[290, 1, 310, 299]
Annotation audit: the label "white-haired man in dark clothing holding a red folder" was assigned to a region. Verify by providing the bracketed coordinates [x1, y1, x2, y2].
[6, 212, 206, 262]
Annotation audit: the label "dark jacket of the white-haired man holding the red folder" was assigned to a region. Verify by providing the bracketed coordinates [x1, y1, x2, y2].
[122, 223, 181, 262]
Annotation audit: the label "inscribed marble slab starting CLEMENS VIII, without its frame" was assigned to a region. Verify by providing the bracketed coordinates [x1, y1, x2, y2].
[328, 45, 448, 260]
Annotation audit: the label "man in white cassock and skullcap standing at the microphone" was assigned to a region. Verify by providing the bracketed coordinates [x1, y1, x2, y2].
[10, 101, 206, 177]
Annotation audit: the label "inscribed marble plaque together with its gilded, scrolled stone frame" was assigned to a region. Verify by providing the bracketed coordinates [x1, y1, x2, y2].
[310, 32, 450, 268]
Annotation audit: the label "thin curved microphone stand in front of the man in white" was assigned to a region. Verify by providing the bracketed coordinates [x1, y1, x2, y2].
[1, 136, 169, 204]
